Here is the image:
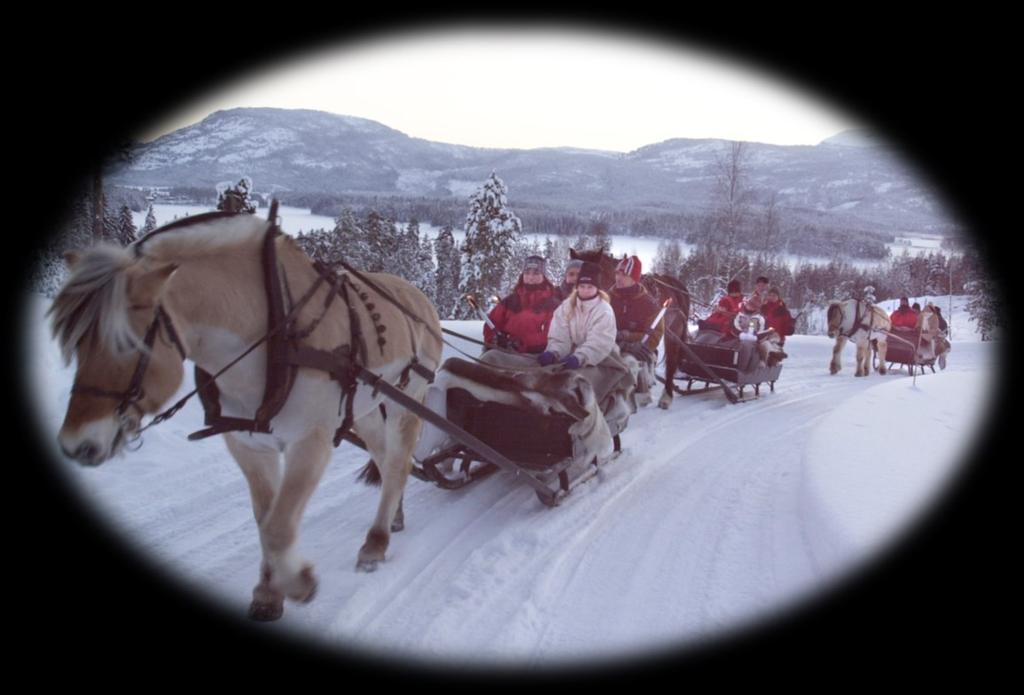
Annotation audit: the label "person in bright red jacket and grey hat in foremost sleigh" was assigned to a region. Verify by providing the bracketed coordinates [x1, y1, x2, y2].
[483, 256, 561, 354]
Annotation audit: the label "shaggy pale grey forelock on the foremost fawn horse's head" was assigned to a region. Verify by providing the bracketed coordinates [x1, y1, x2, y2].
[46, 244, 145, 364]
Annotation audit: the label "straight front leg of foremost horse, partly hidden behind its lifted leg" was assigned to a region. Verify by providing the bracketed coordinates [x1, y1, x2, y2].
[224, 433, 285, 620]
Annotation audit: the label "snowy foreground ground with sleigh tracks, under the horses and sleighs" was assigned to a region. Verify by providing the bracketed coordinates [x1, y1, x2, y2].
[24, 295, 997, 666]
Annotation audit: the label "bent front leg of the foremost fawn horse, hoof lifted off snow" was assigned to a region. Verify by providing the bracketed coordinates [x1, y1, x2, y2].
[244, 427, 331, 619]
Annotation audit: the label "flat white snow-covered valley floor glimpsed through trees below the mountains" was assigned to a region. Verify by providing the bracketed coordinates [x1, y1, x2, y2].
[132, 204, 949, 276]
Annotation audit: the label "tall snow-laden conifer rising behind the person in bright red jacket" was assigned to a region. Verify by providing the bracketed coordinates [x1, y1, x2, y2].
[459, 172, 522, 318]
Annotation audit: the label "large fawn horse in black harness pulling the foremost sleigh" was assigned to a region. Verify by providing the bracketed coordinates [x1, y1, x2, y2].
[48, 212, 441, 620]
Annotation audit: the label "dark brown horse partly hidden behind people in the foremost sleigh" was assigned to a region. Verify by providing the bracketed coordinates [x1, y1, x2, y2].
[569, 248, 690, 410]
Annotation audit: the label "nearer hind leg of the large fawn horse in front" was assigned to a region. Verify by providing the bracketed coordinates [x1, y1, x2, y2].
[355, 405, 422, 572]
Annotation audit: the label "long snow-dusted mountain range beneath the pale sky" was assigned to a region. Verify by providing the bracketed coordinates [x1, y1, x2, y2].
[108, 108, 951, 231]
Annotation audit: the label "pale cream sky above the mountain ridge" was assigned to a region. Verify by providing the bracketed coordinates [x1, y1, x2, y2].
[138, 27, 861, 151]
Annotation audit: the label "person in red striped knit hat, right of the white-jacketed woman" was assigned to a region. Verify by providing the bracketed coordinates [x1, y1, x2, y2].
[611, 256, 665, 405]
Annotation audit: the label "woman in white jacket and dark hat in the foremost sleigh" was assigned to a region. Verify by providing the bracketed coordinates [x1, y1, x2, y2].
[537, 262, 616, 370]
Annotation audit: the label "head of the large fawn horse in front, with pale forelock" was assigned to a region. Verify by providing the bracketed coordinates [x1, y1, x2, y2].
[48, 246, 184, 466]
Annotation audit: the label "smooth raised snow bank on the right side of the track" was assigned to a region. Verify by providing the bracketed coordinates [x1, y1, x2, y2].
[801, 372, 992, 569]
